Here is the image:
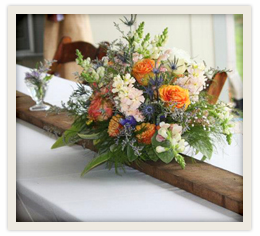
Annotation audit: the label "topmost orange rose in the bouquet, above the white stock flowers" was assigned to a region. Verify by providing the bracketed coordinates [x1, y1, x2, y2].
[132, 59, 155, 86]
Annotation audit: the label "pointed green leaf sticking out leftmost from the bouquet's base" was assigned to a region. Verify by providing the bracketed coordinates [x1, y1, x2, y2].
[51, 125, 80, 149]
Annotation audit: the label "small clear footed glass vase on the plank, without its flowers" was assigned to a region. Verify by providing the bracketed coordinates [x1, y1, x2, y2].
[25, 81, 50, 111]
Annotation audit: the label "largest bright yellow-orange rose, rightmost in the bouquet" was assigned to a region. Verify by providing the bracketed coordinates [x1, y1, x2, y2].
[159, 85, 190, 109]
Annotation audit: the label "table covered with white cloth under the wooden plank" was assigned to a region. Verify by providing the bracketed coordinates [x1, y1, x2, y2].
[17, 66, 243, 222]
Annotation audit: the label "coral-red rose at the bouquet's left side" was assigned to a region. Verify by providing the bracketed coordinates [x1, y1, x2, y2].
[88, 96, 113, 121]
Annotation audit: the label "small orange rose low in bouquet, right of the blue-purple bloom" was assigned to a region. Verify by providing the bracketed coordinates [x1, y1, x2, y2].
[136, 123, 156, 144]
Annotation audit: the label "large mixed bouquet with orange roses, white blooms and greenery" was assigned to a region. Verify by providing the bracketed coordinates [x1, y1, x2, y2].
[52, 16, 235, 175]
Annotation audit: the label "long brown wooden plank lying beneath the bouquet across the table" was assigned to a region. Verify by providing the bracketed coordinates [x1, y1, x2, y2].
[16, 92, 243, 215]
